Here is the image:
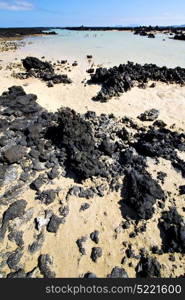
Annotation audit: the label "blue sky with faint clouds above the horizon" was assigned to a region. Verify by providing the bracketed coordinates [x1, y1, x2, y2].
[0, 0, 185, 27]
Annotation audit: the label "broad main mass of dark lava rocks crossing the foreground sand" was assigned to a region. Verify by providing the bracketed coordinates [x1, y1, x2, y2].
[0, 87, 185, 225]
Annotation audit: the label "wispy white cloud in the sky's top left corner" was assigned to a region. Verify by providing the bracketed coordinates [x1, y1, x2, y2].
[0, 0, 34, 11]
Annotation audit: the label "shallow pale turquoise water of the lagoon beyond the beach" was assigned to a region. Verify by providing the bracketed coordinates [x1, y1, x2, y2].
[23, 30, 185, 67]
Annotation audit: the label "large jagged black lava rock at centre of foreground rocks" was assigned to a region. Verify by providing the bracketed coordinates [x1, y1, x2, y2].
[48, 108, 107, 181]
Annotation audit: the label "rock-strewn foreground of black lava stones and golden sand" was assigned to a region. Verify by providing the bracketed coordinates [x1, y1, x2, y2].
[0, 85, 185, 278]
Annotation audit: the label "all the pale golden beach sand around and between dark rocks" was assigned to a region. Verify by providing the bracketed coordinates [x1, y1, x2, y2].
[0, 31, 185, 278]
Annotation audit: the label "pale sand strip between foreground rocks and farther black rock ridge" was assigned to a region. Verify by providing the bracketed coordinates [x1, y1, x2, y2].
[0, 52, 185, 128]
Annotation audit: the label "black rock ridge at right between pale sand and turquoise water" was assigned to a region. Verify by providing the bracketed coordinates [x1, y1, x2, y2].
[90, 62, 185, 102]
